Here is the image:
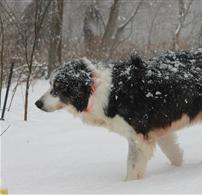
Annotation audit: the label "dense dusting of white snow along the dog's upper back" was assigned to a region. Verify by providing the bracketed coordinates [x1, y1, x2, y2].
[144, 48, 202, 83]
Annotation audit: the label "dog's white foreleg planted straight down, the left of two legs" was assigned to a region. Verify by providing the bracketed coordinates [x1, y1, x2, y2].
[126, 140, 154, 180]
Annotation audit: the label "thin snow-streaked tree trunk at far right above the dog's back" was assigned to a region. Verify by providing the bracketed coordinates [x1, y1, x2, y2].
[173, 0, 194, 49]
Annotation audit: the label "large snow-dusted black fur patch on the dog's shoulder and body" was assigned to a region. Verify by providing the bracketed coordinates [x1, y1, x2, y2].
[105, 48, 202, 135]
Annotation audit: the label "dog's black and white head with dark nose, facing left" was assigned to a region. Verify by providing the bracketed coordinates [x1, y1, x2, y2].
[35, 59, 93, 112]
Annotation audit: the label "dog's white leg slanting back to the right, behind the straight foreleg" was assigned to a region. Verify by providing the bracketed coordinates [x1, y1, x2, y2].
[158, 133, 183, 166]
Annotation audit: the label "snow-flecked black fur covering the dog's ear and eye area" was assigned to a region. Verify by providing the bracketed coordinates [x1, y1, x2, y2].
[51, 60, 93, 112]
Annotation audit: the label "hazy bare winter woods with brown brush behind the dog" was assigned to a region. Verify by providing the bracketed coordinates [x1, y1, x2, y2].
[0, 0, 202, 120]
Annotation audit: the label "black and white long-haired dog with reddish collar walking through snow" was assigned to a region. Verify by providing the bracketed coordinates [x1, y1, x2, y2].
[36, 48, 202, 180]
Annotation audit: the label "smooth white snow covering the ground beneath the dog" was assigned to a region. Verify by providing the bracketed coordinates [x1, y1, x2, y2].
[0, 81, 202, 194]
